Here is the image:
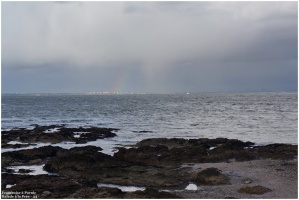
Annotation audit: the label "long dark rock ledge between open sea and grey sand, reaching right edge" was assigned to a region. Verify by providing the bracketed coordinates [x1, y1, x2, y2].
[114, 138, 298, 166]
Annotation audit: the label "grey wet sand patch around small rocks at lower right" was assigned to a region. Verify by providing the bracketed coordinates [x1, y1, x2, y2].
[172, 159, 298, 199]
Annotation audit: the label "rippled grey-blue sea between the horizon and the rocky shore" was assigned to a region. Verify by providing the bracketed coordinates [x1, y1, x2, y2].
[1, 93, 298, 149]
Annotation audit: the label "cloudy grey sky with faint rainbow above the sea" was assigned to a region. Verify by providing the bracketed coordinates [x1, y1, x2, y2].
[1, 1, 298, 93]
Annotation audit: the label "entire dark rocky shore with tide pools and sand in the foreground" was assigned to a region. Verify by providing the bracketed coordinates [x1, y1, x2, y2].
[1, 125, 298, 199]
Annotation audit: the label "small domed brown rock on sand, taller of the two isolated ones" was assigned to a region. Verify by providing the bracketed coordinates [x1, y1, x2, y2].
[194, 168, 230, 185]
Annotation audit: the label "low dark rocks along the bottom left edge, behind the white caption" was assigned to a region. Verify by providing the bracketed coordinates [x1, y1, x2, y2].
[1, 174, 183, 199]
